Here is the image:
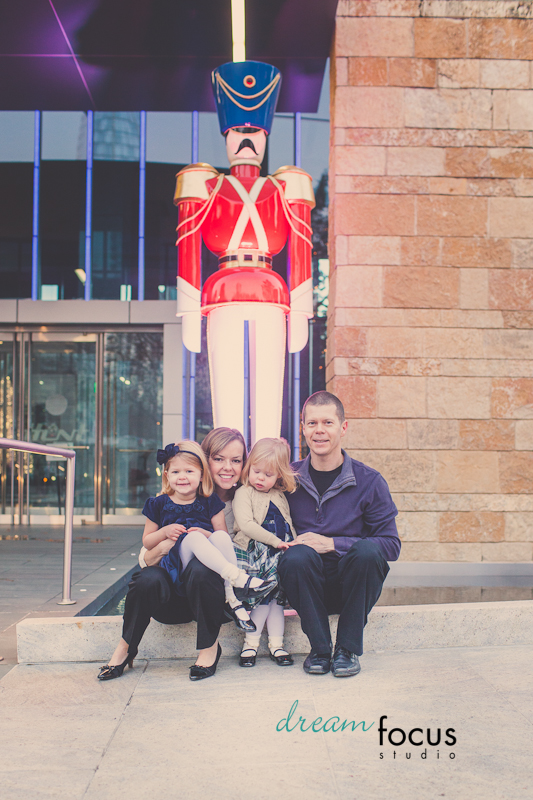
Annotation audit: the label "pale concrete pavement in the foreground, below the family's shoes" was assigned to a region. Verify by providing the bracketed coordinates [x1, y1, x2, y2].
[0, 646, 533, 800]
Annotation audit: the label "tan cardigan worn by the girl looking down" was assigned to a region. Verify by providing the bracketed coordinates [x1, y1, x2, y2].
[233, 486, 296, 550]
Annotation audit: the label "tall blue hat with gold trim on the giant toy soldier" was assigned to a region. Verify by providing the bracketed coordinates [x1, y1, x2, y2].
[211, 61, 281, 134]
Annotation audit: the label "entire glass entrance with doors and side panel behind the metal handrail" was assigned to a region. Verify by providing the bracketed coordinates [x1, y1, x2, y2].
[0, 330, 163, 524]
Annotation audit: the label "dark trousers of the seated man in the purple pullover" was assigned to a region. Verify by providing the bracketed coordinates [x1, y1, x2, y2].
[278, 539, 389, 656]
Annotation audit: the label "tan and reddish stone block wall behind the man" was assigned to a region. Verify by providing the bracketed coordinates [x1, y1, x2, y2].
[327, 0, 533, 561]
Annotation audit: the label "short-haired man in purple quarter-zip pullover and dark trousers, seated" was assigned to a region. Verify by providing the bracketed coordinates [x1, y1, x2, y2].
[278, 392, 401, 678]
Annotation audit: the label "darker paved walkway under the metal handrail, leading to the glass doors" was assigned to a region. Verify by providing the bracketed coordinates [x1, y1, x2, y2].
[0, 525, 142, 677]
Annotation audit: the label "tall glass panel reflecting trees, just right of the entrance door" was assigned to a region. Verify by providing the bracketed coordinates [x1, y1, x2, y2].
[103, 333, 163, 514]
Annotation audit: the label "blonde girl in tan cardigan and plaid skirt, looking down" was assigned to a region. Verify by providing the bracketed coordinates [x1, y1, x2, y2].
[233, 439, 296, 667]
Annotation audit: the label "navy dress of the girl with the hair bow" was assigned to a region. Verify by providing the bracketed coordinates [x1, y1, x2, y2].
[143, 493, 225, 595]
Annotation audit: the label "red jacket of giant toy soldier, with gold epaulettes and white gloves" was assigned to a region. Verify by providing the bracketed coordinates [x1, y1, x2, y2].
[174, 163, 315, 352]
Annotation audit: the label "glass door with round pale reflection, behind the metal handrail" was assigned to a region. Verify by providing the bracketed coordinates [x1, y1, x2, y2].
[26, 332, 98, 522]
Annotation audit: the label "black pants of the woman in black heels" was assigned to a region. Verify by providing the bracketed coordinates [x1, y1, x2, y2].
[122, 558, 227, 652]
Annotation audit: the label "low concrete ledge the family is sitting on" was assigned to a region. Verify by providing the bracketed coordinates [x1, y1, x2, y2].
[17, 600, 533, 664]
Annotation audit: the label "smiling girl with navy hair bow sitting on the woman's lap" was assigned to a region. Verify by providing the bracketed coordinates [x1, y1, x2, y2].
[143, 440, 263, 630]
